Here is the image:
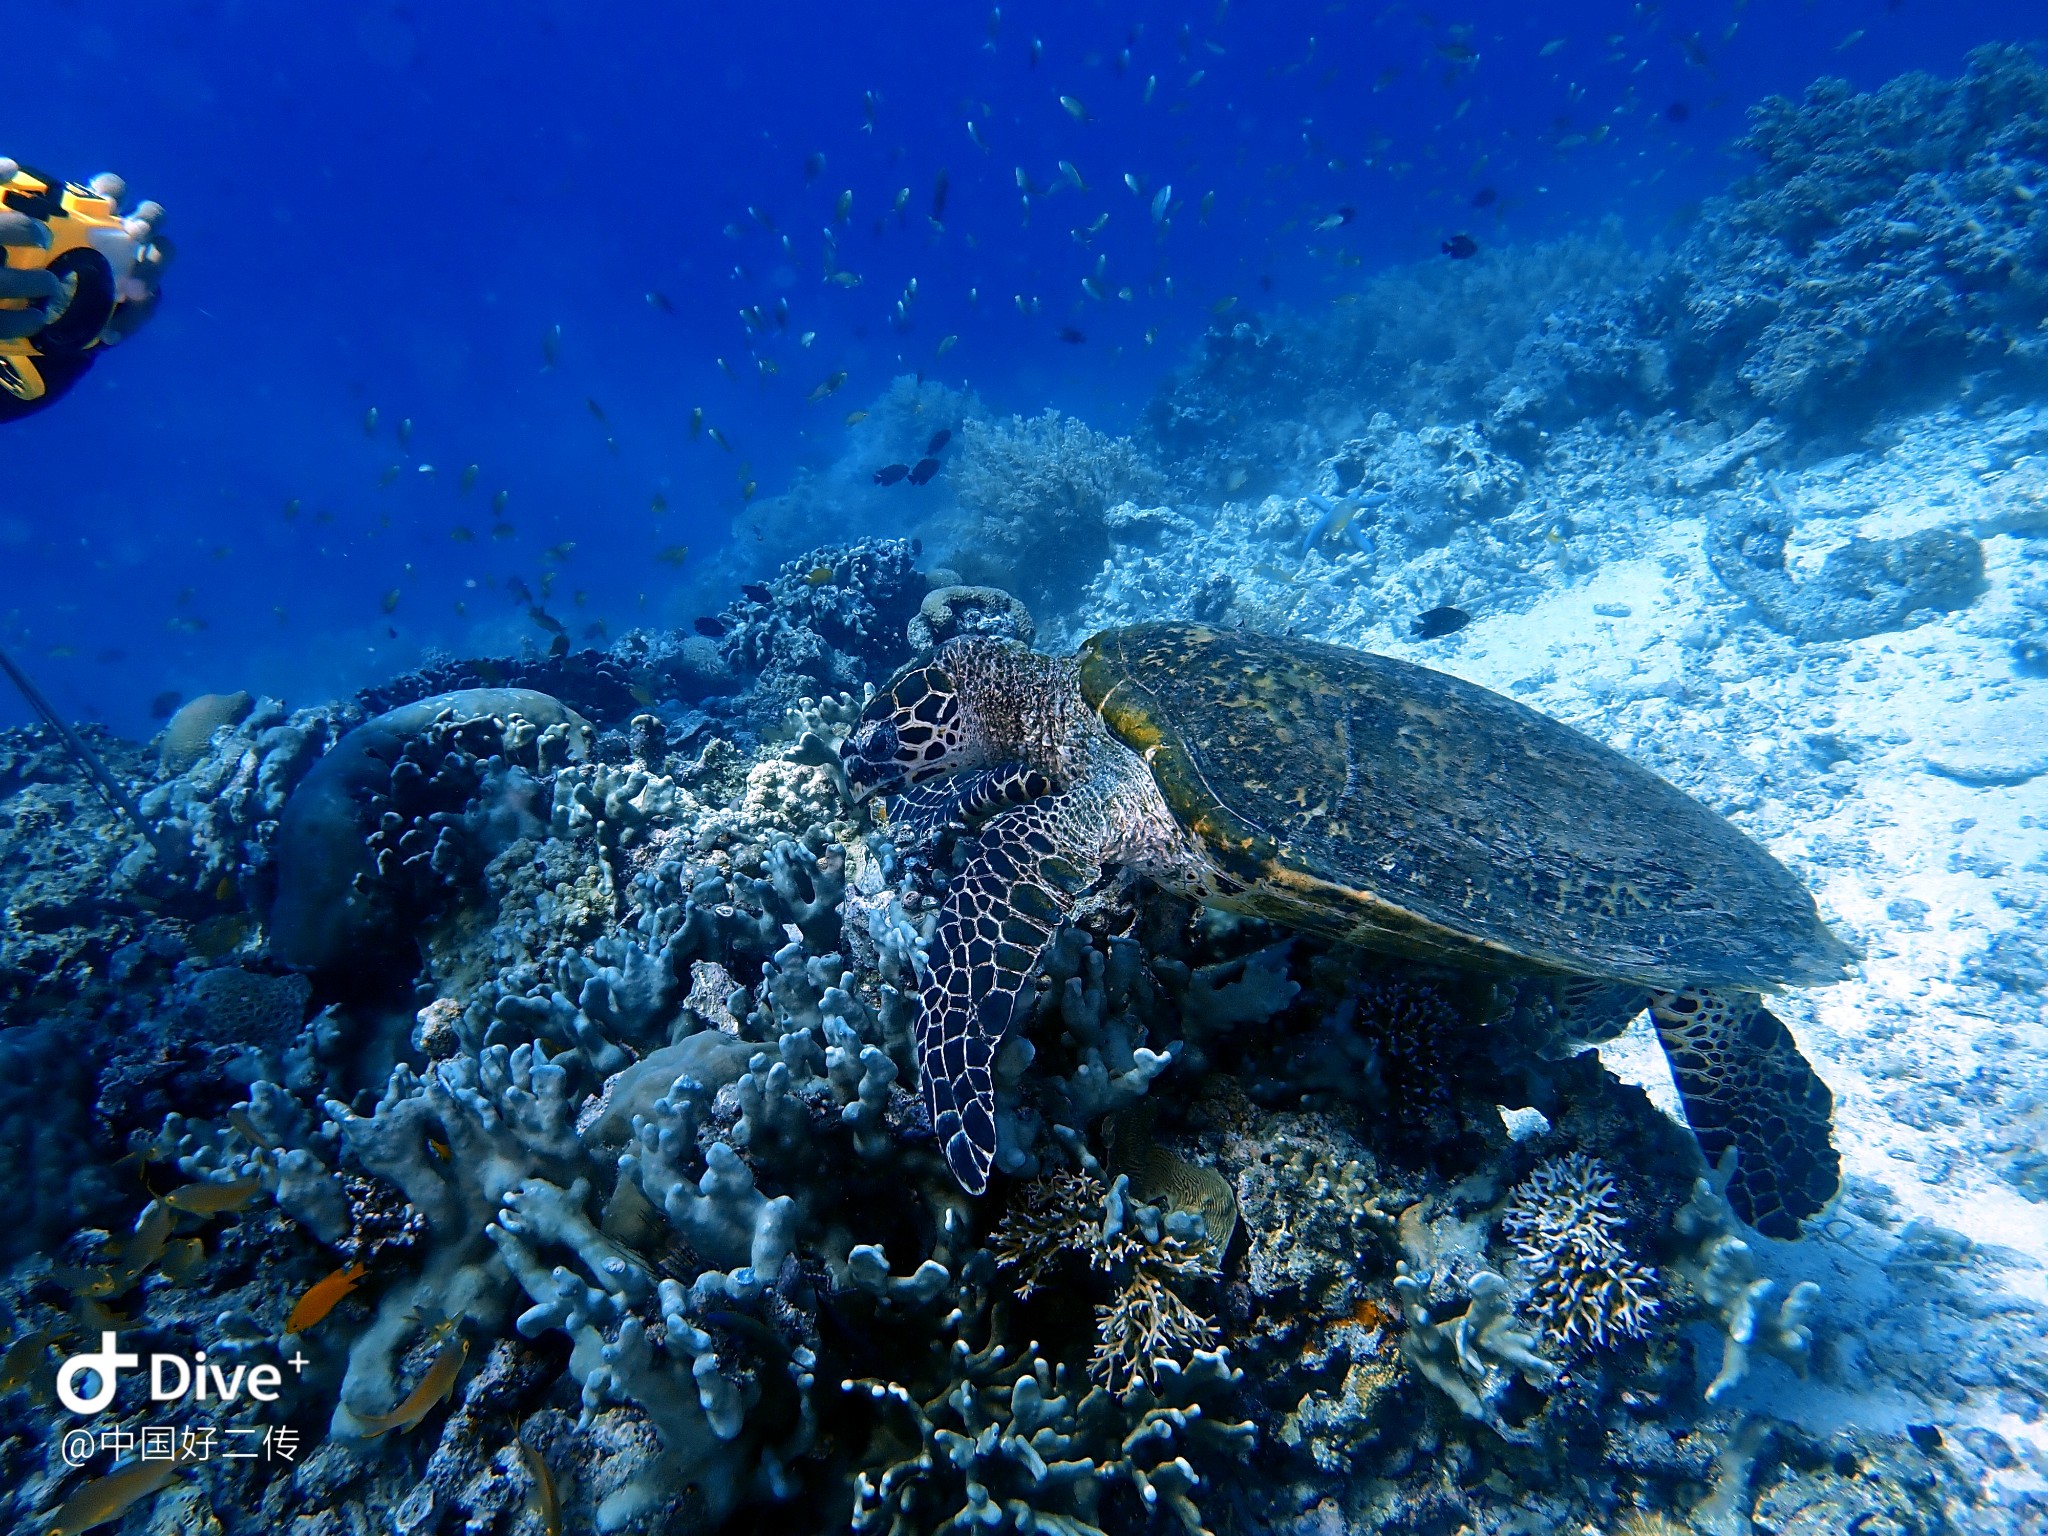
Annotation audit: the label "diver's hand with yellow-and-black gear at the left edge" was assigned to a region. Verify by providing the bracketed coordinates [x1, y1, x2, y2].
[0, 156, 170, 422]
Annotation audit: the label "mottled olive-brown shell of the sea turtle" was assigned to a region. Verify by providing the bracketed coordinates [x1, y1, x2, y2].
[1079, 625, 1851, 991]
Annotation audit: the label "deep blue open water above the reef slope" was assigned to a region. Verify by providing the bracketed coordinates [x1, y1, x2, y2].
[0, 0, 2038, 733]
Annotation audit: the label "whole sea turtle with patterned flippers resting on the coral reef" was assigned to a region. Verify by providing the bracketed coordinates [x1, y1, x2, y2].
[840, 623, 1851, 1237]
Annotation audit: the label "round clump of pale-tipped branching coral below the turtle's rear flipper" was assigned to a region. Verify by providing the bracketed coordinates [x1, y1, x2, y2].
[1501, 1151, 1657, 1352]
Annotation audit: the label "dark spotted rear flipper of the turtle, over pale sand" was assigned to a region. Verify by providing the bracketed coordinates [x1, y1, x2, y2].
[1651, 989, 1841, 1239]
